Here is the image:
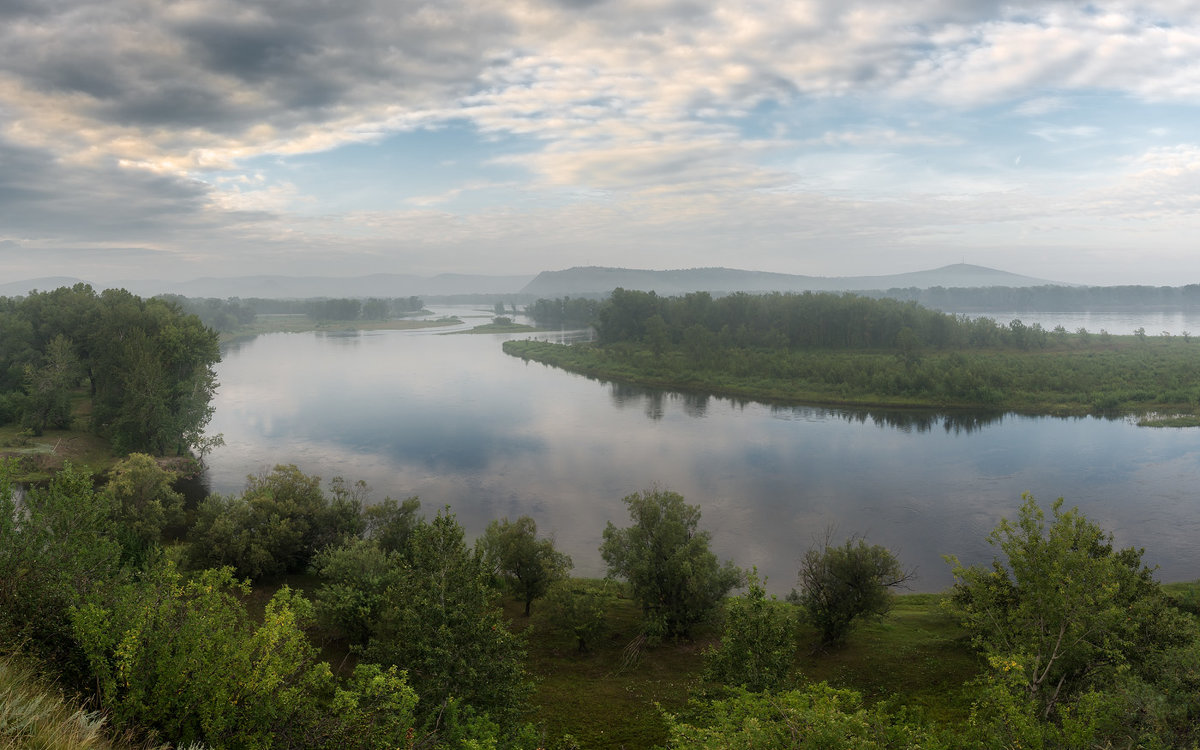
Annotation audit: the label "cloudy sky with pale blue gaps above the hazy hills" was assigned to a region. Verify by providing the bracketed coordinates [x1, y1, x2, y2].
[0, 0, 1200, 286]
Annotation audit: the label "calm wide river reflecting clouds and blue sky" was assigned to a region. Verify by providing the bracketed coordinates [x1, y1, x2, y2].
[206, 309, 1200, 593]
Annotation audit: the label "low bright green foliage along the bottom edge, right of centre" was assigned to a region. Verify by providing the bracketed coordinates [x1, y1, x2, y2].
[666, 683, 945, 750]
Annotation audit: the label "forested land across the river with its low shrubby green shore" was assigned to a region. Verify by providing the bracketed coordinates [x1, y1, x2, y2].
[504, 289, 1200, 424]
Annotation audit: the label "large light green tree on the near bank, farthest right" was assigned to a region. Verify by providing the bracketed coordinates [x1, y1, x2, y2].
[948, 494, 1196, 719]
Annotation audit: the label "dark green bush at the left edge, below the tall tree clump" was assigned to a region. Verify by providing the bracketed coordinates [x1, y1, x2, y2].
[0, 463, 120, 677]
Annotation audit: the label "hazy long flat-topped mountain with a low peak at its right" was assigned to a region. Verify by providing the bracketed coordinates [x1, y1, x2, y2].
[521, 263, 1070, 298]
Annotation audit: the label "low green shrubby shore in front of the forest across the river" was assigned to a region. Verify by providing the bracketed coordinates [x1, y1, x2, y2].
[504, 336, 1200, 417]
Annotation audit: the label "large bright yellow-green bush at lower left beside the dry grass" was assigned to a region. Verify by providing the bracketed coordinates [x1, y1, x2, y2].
[72, 563, 332, 748]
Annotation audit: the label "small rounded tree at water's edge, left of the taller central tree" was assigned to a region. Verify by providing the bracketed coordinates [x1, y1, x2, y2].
[476, 516, 574, 617]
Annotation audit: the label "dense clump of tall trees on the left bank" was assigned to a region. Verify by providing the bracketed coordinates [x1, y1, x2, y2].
[0, 284, 220, 455]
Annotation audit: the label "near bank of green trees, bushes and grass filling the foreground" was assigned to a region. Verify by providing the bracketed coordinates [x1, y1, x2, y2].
[0, 454, 1200, 750]
